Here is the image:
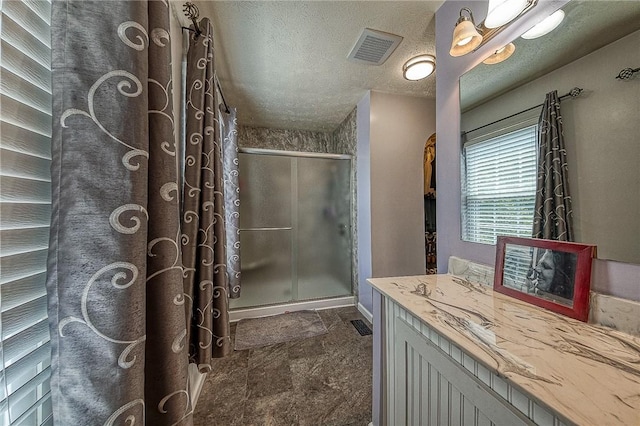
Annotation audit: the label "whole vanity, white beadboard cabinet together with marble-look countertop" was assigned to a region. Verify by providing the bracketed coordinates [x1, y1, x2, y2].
[369, 275, 640, 426]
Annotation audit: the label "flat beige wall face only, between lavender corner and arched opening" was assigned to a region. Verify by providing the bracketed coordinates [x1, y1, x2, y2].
[369, 92, 435, 277]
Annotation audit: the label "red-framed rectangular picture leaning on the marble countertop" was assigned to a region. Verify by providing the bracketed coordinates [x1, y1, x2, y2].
[493, 237, 596, 321]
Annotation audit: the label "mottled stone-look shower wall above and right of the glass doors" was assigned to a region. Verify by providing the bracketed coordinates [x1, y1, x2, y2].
[238, 108, 358, 302]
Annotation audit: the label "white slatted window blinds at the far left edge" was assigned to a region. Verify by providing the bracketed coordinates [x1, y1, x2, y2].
[0, 0, 53, 425]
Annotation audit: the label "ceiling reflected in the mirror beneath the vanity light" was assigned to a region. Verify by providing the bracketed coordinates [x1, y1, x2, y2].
[460, 0, 640, 110]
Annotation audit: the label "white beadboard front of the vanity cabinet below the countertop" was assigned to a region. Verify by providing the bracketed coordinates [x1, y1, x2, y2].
[386, 299, 562, 426]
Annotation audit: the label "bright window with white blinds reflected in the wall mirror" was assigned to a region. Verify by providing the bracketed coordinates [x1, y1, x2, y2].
[462, 122, 538, 244]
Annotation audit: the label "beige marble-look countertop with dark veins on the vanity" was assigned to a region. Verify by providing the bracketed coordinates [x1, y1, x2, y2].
[368, 275, 640, 425]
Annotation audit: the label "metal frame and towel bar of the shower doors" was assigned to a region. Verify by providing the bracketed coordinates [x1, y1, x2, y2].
[235, 148, 356, 310]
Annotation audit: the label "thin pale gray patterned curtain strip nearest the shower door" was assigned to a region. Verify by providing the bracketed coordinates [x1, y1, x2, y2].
[218, 103, 240, 299]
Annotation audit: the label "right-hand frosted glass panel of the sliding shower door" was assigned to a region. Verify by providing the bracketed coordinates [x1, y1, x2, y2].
[295, 157, 352, 300]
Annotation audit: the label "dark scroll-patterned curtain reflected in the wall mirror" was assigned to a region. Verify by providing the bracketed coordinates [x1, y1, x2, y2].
[533, 90, 573, 241]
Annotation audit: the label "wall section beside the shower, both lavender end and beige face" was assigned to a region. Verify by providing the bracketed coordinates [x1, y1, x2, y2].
[356, 92, 436, 312]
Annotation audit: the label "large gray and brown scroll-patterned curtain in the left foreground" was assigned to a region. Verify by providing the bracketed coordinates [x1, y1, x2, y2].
[47, 0, 193, 425]
